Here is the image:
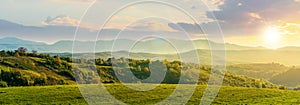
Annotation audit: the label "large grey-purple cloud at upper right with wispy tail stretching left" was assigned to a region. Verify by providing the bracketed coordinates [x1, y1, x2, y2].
[169, 0, 300, 37]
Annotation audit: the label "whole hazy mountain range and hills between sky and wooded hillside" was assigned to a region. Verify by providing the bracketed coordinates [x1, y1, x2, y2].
[0, 38, 300, 65]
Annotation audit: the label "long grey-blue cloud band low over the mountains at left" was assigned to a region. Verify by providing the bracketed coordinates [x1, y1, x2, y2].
[0, 19, 188, 43]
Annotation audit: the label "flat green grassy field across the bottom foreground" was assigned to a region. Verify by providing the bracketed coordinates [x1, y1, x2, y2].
[0, 84, 300, 105]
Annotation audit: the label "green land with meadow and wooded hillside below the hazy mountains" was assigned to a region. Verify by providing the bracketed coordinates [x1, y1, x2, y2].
[0, 51, 300, 105]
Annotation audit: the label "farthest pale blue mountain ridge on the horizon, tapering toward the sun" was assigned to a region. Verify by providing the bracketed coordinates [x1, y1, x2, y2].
[0, 37, 265, 54]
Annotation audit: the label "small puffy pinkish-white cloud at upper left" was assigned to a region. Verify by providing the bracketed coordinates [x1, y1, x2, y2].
[42, 15, 79, 26]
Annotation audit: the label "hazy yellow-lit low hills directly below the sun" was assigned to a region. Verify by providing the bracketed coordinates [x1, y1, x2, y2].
[183, 49, 300, 66]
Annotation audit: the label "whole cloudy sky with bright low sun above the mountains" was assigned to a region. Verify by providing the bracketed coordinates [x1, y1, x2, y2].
[0, 0, 300, 48]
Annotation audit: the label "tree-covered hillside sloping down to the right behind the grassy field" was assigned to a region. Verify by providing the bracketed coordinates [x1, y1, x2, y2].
[0, 51, 277, 88]
